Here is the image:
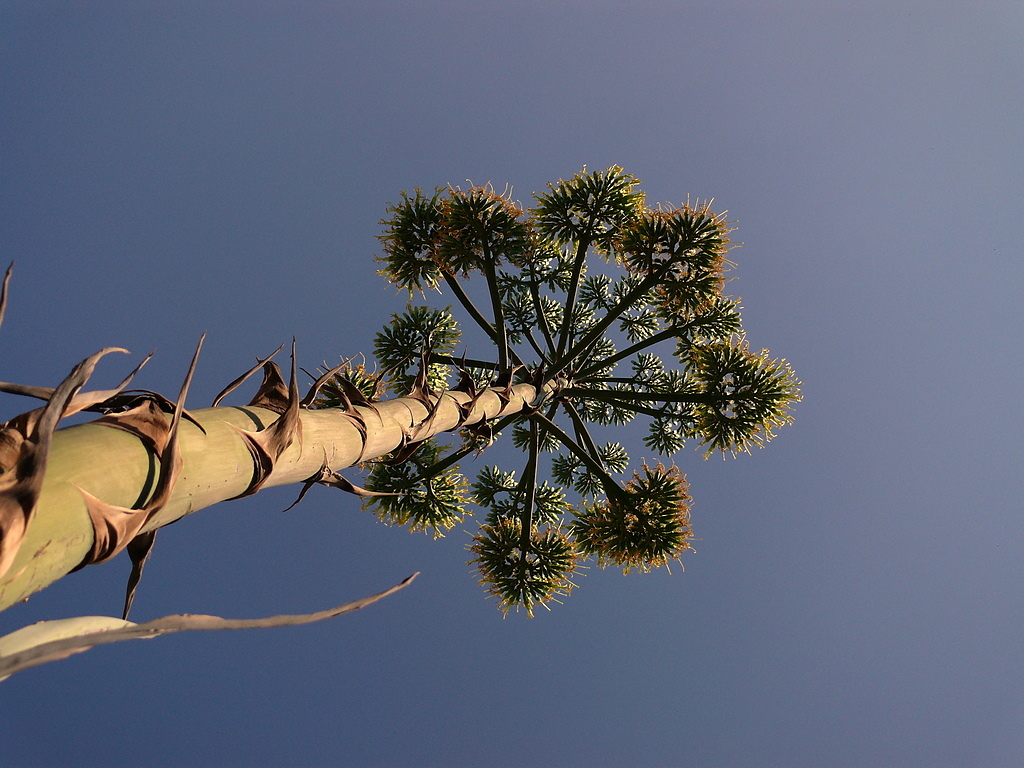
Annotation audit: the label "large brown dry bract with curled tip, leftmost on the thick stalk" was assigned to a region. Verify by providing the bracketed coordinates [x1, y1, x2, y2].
[0, 347, 127, 575]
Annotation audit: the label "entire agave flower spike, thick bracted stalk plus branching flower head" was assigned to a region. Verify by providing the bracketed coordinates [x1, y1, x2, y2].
[0, 167, 800, 615]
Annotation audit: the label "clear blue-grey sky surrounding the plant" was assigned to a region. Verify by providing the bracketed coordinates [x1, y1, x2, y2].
[0, 0, 1024, 768]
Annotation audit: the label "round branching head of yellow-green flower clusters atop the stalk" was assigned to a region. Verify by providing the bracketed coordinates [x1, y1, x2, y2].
[344, 167, 800, 614]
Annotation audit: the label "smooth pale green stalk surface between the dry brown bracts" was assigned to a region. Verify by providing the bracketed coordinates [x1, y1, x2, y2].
[0, 384, 538, 610]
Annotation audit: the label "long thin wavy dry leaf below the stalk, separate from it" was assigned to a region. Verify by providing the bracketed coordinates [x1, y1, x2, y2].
[0, 573, 419, 680]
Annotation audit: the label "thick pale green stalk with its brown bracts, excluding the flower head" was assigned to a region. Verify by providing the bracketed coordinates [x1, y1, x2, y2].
[0, 342, 552, 607]
